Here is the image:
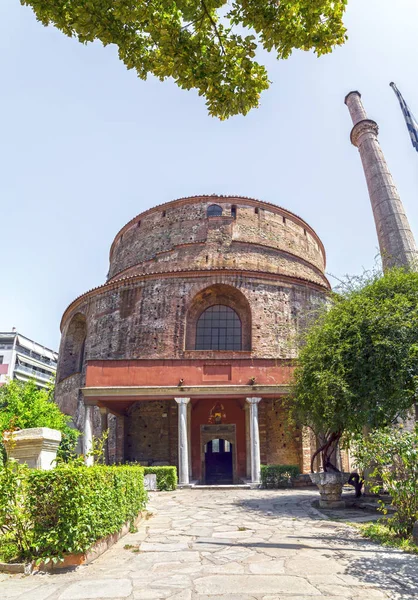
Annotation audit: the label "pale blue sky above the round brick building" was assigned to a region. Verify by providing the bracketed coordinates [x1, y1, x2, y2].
[0, 0, 418, 348]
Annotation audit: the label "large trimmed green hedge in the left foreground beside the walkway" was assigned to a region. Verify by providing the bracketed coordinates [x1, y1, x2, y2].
[0, 463, 147, 559]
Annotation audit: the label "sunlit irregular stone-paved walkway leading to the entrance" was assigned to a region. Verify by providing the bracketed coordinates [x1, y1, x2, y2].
[0, 490, 418, 600]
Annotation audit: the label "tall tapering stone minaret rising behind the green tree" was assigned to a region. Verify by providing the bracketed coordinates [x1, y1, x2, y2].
[345, 92, 418, 271]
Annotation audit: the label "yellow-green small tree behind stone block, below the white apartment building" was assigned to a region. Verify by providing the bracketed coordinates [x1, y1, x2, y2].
[0, 380, 79, 458]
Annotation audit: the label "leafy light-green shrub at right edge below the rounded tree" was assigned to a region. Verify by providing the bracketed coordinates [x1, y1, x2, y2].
[354, 424, 418, 538]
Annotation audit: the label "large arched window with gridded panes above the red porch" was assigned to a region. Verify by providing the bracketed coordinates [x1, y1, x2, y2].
[196, 304, 242, 350]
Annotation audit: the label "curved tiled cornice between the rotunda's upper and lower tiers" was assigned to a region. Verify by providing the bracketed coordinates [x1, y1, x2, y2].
[60, 269, 331, 332]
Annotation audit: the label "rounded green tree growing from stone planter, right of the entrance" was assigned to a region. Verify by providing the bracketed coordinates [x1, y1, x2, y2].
[293, 269, 418, 471]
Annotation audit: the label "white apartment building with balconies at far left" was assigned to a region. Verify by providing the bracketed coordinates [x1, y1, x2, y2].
[0, 329, 58, 388]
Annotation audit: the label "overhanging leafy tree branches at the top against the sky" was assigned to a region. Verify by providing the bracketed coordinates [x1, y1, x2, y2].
[21, 0, 347, 119]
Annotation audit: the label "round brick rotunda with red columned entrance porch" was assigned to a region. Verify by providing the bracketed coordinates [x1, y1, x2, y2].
[56, 196, 330, 485]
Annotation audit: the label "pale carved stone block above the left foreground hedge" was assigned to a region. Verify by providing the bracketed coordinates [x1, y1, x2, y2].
[3, 427, 61, 471]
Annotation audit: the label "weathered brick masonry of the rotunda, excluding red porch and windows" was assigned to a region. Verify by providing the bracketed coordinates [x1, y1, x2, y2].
[56, 197, 329, 478]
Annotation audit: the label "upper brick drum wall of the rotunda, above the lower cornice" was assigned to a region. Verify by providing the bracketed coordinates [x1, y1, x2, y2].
[109, 197, 325, 283]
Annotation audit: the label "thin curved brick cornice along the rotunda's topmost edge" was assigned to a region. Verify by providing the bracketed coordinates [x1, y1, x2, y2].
[109, 194, 326, 264]
